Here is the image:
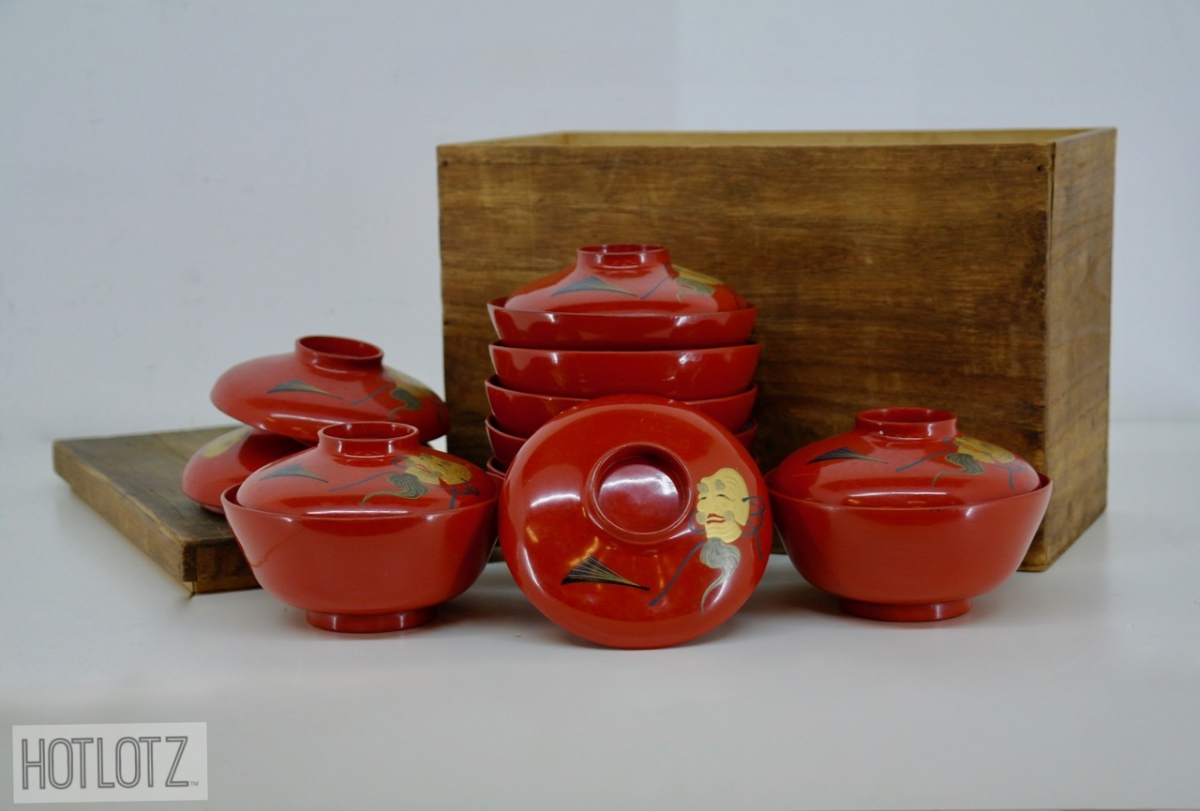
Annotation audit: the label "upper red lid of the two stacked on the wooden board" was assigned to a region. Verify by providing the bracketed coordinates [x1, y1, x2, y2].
[211, 335, 450, 444]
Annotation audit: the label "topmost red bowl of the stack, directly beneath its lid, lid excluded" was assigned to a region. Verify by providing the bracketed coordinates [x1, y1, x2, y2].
[487, 299, 758, 349]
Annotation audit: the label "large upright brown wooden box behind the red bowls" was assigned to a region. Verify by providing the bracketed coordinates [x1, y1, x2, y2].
[438, 128, 1116, 570]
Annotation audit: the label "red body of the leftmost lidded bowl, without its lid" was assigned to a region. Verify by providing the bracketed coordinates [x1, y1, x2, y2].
[222, 486, 497, 633]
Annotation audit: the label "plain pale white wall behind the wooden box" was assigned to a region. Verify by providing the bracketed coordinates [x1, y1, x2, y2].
[0, 0, 1200, 441]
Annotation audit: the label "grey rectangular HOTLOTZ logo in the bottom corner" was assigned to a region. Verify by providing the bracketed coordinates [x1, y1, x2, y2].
[12, 723, 209, 803]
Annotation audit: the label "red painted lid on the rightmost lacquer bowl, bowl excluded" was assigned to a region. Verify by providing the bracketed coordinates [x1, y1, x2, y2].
[767, 408, 1038, 506]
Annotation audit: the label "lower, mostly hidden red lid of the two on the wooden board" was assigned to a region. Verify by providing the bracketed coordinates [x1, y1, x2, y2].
[180, 426, 310, 512]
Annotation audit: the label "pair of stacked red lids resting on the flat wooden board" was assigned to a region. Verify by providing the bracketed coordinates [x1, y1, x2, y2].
[181, 335, 450, 512]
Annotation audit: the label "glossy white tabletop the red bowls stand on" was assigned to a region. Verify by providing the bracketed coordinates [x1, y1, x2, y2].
[0, 423, 1200, 810]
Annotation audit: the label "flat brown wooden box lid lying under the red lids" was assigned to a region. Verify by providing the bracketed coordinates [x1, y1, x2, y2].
[54, 426, 258, 594]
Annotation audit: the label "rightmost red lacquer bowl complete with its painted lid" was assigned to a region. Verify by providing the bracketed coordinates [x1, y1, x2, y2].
[767, 407, 1051, 621]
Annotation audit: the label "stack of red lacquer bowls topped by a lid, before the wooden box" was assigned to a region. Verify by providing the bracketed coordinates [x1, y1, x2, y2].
[485, 244, 760, 475]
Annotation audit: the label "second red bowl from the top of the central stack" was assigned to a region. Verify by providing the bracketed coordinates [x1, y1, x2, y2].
[490, 343, 761, 400]
